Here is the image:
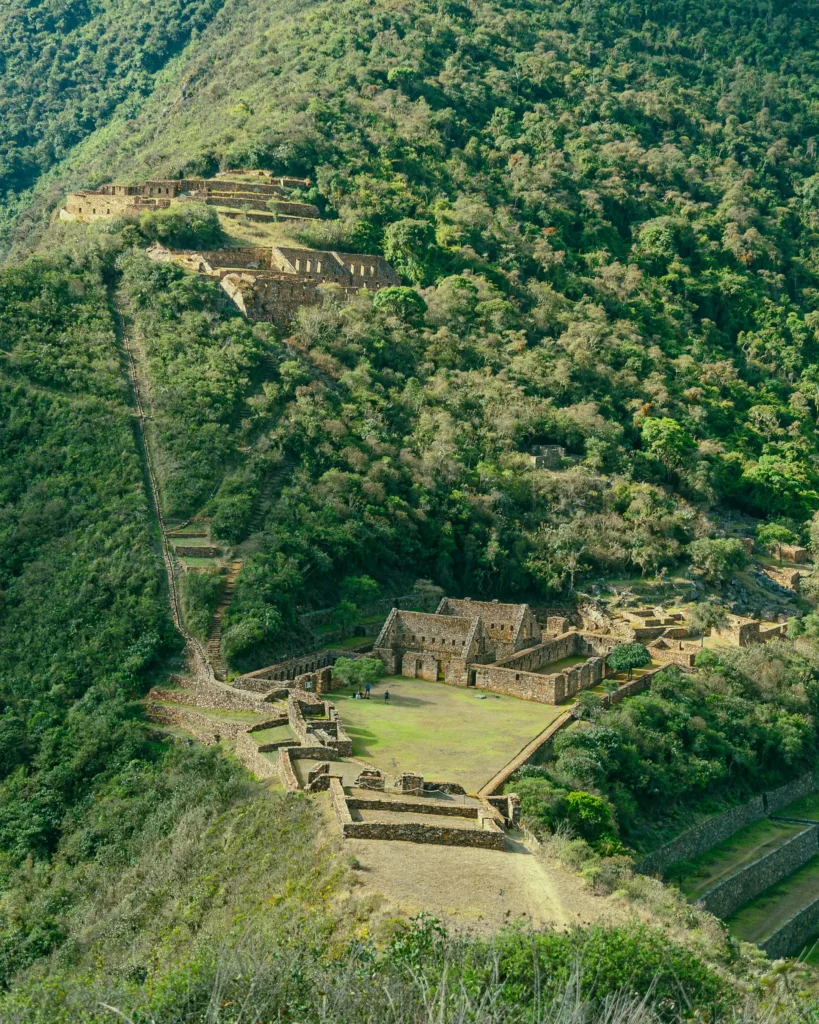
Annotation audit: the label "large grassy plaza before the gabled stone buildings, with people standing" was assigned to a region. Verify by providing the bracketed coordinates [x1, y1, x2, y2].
[331, 677, 563, 793]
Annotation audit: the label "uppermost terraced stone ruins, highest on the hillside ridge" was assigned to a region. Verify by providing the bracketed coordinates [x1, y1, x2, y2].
[59, 171, 319, 222]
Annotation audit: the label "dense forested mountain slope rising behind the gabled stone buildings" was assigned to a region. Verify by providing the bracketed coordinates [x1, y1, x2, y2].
[15, 3, 819, 666]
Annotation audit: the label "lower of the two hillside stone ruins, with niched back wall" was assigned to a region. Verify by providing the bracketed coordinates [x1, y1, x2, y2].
[146, 243, 401, 329]
